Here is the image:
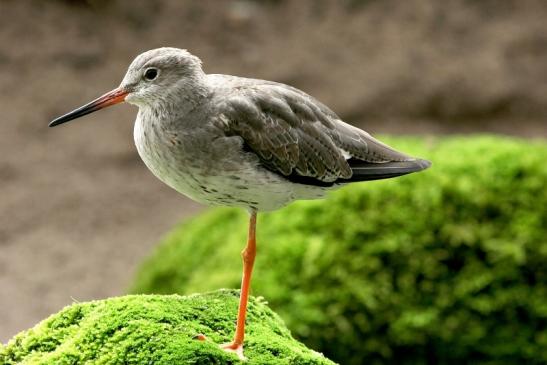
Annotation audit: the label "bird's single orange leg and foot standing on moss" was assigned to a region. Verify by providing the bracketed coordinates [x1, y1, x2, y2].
[221, 211, 256, 360]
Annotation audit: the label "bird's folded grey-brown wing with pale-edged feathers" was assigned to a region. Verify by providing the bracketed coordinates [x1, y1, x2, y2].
[214, 82, 428, 185]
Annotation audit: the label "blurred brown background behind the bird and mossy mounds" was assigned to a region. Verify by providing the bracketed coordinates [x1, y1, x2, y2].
[0, 0, 547, 362]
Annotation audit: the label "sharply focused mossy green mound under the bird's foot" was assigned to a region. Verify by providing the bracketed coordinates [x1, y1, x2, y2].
[0, 290, 334, 365]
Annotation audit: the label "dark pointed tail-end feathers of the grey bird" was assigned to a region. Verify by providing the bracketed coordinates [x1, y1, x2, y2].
[346, 158, 431, 183]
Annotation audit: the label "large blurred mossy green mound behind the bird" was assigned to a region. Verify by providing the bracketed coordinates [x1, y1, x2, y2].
[132, 136, 547, 364]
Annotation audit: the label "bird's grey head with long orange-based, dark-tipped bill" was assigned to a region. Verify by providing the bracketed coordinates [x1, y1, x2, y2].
[49, 47, 203, 127]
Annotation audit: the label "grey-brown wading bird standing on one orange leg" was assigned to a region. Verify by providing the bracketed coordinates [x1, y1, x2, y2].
[49, 47, 431, 360]
